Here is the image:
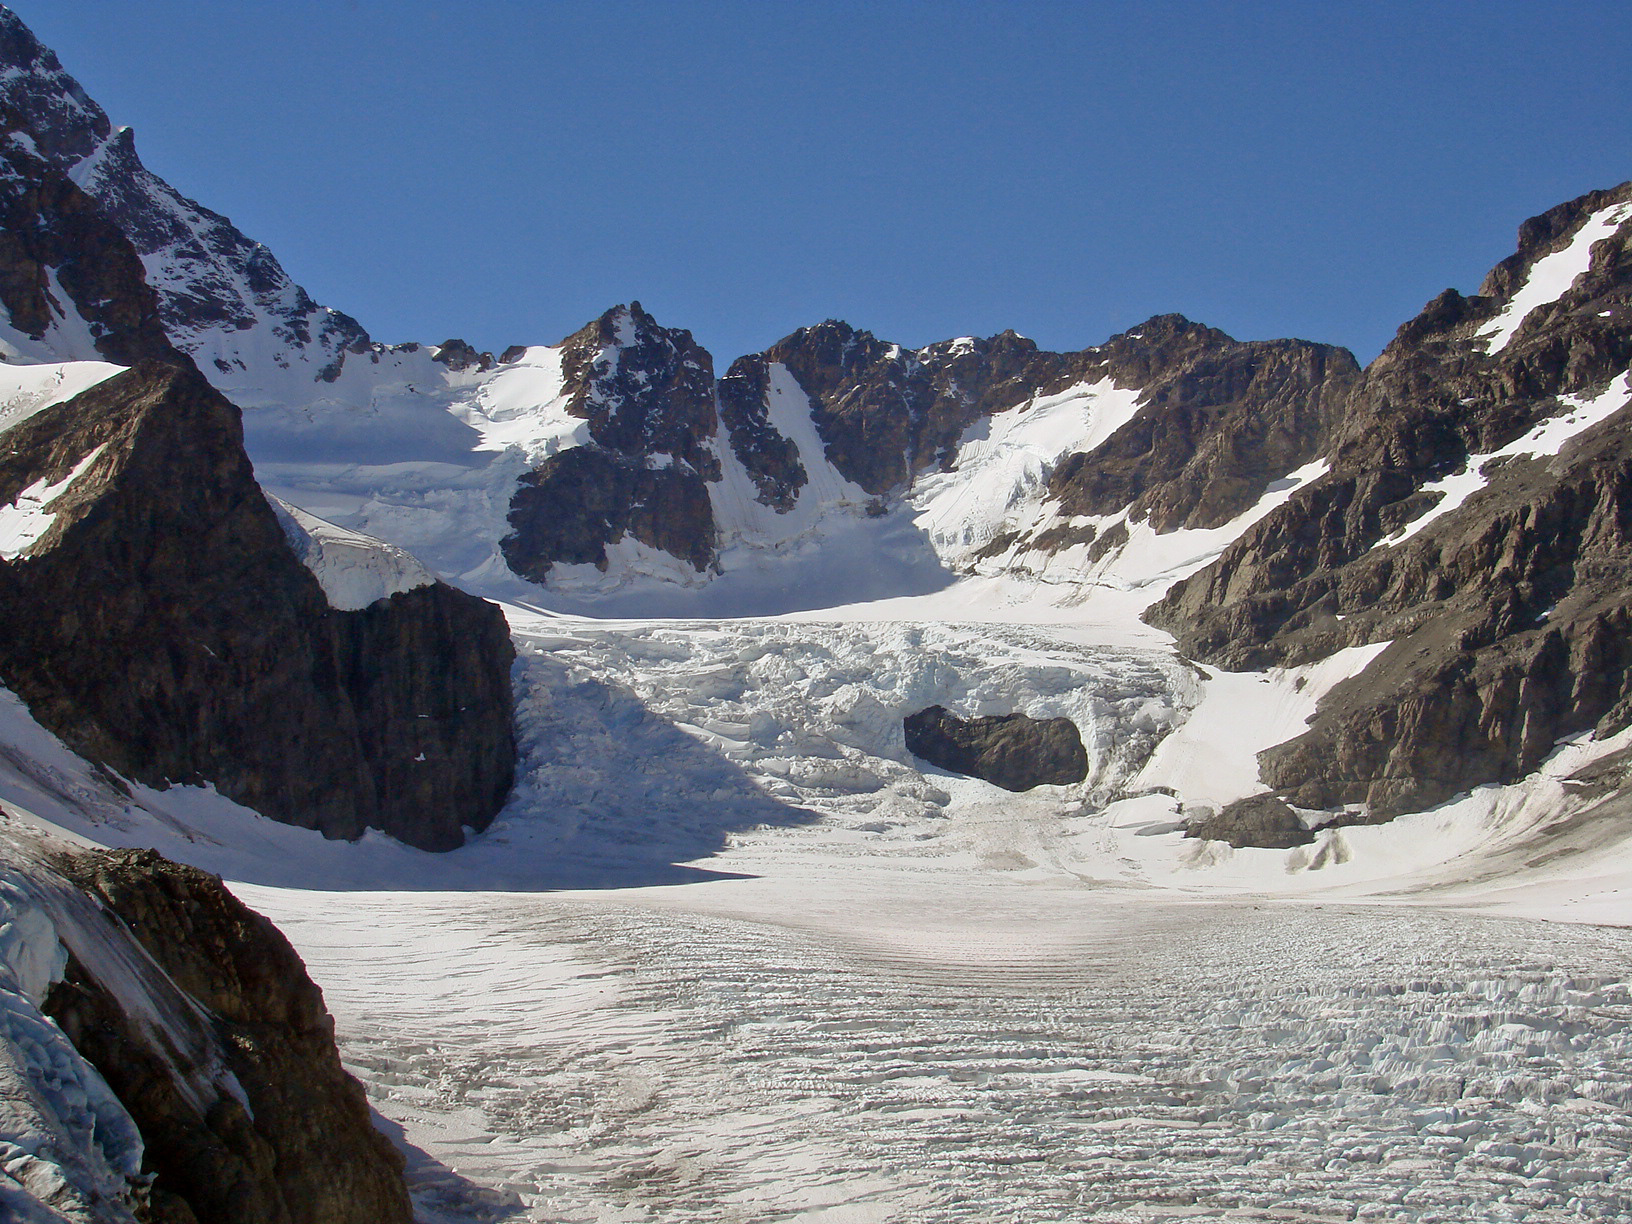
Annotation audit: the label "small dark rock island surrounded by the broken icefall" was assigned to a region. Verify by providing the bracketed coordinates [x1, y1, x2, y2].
[901, 705, 1089, 792]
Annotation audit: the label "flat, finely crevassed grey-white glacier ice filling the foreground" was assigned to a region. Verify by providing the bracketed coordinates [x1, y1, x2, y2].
[246, 870, 1632, 1224]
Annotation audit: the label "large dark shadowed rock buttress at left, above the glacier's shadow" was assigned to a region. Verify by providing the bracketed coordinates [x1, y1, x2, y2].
[0, 362, 514, 849]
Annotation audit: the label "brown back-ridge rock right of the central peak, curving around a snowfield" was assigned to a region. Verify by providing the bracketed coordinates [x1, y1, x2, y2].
[762, 315, 1359, 548]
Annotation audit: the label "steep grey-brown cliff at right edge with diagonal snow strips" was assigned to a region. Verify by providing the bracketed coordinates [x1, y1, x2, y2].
[1151, 184, 1632, 819]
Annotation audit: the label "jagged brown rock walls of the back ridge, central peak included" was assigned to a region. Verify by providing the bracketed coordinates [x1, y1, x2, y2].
[504, 304, 1358, 581]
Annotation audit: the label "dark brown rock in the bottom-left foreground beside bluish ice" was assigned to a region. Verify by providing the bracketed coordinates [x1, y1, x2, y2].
[46, 850, 411, 1224]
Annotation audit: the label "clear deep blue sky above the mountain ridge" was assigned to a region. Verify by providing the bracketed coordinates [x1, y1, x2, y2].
[13, 0, 1632, 370]
